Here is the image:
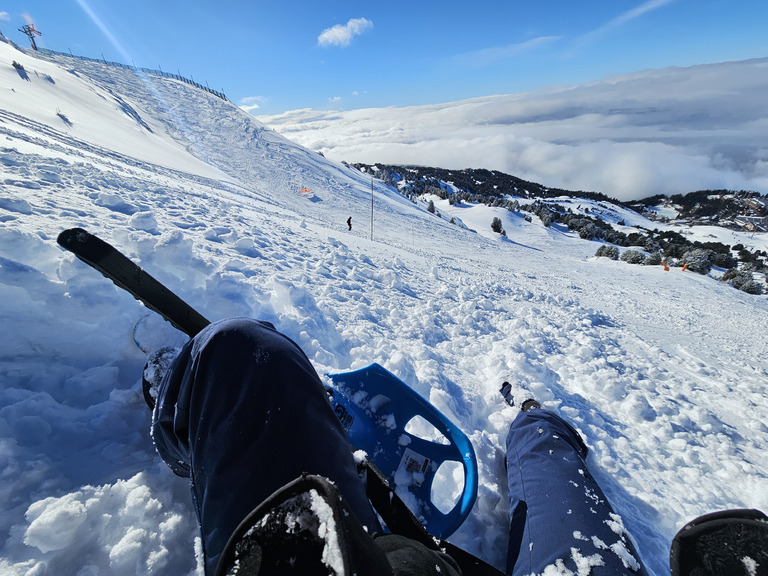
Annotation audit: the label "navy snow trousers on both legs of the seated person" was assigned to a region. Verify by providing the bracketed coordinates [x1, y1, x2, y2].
[152, 318, 644, 575]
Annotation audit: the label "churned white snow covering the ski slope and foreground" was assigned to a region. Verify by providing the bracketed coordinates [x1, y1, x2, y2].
[0, 40, 768, 576]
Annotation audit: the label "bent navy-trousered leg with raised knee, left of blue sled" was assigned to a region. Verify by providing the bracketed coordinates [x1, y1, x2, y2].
[153, 319, 381, 574]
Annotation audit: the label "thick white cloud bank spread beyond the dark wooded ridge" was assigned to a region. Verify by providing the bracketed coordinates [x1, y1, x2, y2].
[260, 58, 768, 200]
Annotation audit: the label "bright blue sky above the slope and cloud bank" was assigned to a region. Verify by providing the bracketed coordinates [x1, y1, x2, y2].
[0, 0, 768, 114]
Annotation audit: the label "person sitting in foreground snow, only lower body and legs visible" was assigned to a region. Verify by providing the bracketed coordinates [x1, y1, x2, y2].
[145, 319, 768, 576]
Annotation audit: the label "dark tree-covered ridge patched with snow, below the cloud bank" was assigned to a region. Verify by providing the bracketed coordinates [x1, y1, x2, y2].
[354, 164, 768, 294]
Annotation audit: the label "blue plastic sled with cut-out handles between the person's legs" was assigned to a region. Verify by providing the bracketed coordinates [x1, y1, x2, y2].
[328, 363, 478, 538]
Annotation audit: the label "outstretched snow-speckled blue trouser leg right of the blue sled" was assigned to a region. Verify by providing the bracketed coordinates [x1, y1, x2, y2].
[506, 409, 645, 576]
